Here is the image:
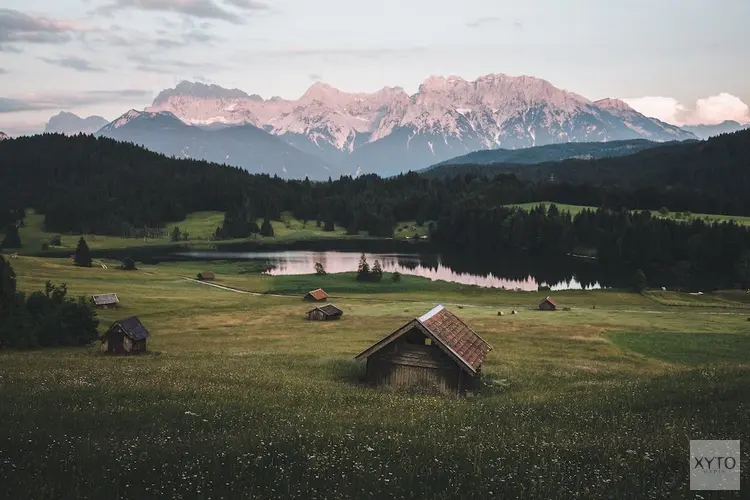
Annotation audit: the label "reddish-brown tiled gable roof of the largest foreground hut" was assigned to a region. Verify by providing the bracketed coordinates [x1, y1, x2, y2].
[356, 305, 492, 374]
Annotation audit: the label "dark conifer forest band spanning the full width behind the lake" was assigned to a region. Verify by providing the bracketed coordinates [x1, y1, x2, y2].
[0, 132, 750, 286]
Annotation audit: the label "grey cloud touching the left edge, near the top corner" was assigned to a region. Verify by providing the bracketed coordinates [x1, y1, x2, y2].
[0, 9, 90, 52]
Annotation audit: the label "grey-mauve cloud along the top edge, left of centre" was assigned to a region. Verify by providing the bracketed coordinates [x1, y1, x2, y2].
[96, 0, 269, 24]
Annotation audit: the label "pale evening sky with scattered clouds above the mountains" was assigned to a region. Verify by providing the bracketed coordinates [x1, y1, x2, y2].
[0, 0, 750, 135]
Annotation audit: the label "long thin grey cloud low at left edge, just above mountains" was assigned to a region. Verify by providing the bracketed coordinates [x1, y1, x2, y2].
[0, 89, 152, 113]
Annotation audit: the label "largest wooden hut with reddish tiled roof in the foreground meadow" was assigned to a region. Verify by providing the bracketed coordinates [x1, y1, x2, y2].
[355, 305, 492, 394]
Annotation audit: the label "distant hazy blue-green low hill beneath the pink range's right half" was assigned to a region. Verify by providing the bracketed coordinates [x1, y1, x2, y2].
[422, 139, 672, 172]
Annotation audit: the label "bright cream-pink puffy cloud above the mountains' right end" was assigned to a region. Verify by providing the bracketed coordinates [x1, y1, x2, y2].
[623, 92, 750, 125]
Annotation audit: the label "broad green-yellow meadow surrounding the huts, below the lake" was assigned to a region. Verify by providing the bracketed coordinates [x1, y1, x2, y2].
[0, 256, 750, 499]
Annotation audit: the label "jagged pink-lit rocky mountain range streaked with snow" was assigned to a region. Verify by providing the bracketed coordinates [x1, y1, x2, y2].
[148, 74, 695, 175]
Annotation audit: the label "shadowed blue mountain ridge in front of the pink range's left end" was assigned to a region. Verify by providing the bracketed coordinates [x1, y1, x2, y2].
[97, 109, 341, 180]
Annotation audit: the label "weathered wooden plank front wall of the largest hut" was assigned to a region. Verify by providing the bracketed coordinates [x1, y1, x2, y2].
[367, 333, 464, 394]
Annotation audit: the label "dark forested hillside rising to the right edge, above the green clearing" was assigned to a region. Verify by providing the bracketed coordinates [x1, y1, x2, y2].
[425, 130, 750, 197]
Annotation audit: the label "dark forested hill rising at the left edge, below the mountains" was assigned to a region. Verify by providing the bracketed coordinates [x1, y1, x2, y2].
[0, 134, 296, 235]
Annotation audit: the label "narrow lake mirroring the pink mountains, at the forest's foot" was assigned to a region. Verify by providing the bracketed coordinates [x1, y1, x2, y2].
[181, 251, 601, 291]
